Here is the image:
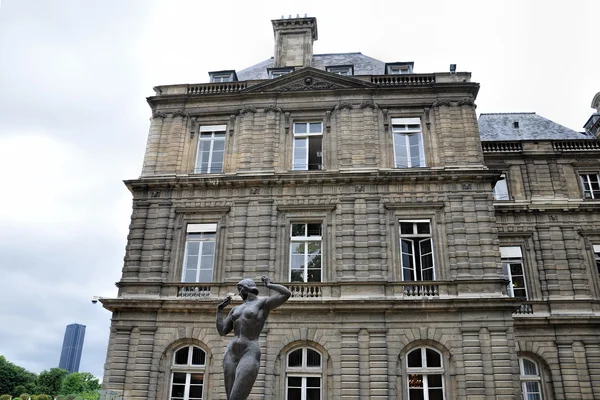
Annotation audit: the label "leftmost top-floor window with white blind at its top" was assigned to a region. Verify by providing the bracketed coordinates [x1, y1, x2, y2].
[194, 125, 227, 174]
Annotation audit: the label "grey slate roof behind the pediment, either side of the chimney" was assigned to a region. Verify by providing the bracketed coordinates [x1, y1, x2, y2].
[237, 53, 385, 81]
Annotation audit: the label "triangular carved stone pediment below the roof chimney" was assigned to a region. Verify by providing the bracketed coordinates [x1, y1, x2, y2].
[243, 67, 377, 93]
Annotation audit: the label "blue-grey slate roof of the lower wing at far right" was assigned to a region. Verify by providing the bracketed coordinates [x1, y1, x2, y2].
[478, 113, 595, 141]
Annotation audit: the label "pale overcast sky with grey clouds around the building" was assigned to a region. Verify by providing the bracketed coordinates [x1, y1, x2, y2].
[0, 0, 600, 378]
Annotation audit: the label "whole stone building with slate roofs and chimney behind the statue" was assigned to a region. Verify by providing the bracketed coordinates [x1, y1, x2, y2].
[101, 17, 600, 400]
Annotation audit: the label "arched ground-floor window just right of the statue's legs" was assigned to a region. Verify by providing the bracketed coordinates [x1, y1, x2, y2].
[285, 347, 323, 400]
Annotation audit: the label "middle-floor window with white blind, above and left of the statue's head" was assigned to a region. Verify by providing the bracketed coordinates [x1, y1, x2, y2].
[181, 224, 217, 282]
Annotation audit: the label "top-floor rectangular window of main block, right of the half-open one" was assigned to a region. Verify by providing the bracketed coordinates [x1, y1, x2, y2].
[392, 118, 425, 168]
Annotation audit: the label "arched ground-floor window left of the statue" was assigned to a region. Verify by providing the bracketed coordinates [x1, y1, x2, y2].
[169, 346, 206, 400]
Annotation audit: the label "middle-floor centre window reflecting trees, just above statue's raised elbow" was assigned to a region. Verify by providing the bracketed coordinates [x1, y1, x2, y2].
[290, 223, 322, 282]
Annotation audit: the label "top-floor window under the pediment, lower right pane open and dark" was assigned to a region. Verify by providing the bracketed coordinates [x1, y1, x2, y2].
[292, 122, 323, 171]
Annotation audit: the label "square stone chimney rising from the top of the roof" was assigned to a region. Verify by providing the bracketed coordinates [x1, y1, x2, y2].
[271, 16, 317, 68]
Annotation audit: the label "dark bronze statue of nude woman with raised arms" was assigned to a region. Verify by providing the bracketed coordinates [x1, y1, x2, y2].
[217, 275, 292, 400]
